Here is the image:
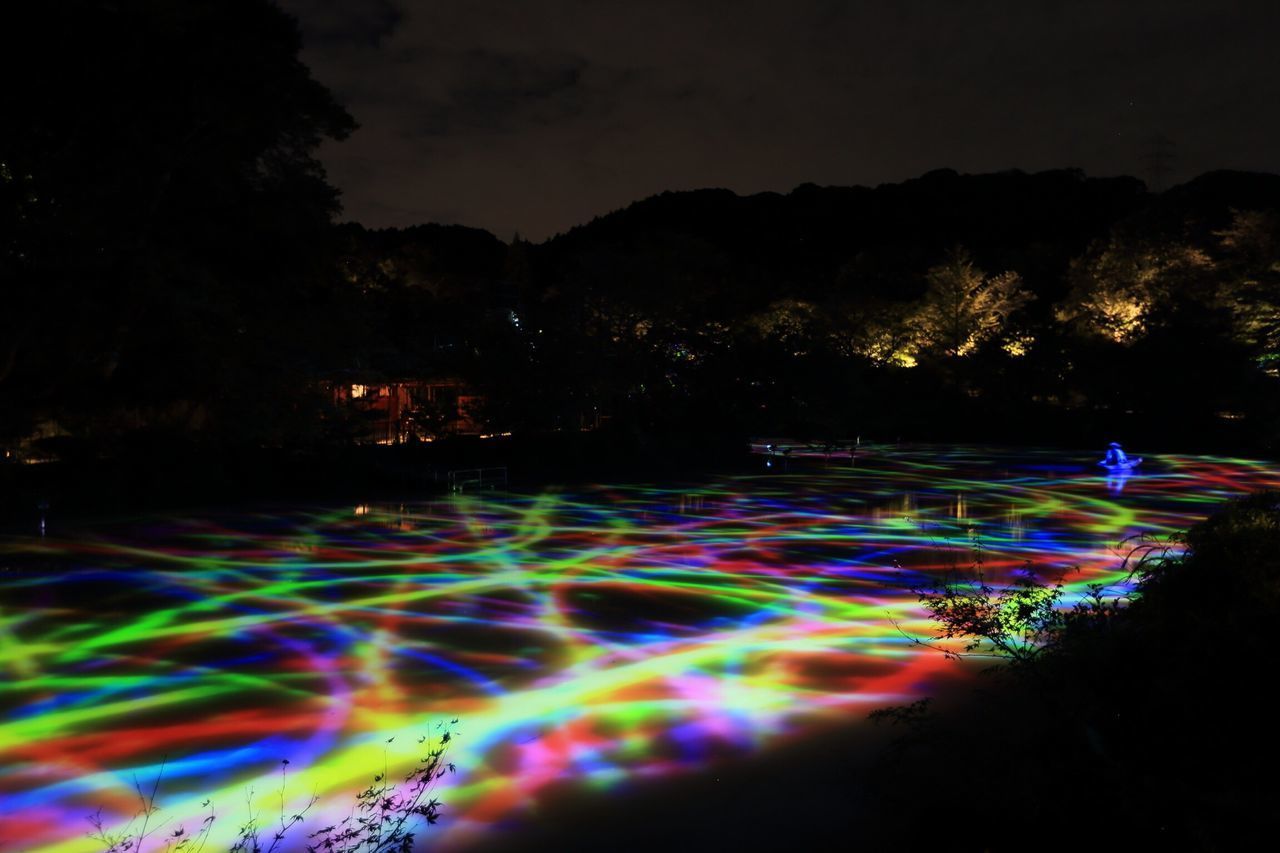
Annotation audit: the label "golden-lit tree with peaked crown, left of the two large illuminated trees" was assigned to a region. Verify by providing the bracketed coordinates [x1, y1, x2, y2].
[913, 248, 1032, 356]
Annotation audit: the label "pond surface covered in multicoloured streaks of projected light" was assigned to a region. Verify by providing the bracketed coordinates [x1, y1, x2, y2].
[0, 448, 1280, 853]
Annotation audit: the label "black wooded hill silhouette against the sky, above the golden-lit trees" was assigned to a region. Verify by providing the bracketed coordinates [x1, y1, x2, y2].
[330, 169, 1280, 322]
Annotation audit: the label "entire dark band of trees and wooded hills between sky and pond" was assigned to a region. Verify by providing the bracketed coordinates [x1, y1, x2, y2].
[0, 0, 1280, 484]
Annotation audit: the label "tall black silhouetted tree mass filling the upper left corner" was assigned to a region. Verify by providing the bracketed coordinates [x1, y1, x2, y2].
[0, 0, 355, 448]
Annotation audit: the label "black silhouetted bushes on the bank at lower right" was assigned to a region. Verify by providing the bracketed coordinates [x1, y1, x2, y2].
[868, 492, 1280, 850]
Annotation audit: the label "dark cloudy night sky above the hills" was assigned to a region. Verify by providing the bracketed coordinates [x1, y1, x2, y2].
[282, 0, 1280, 240]
